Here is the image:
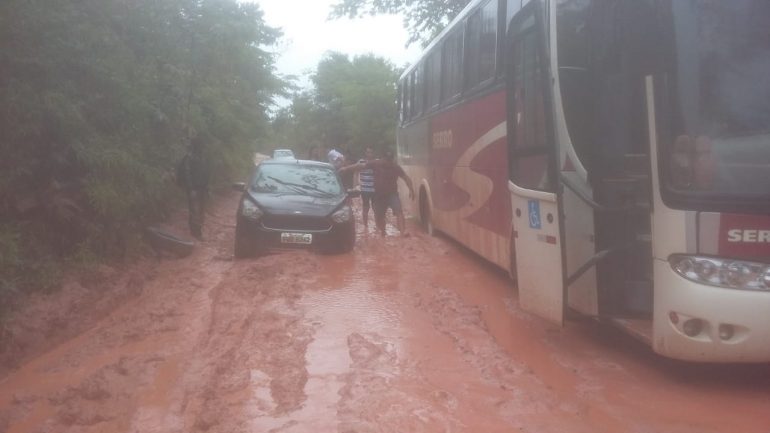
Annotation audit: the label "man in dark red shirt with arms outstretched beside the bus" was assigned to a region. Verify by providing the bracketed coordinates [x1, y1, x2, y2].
[362, 150, 414, 236]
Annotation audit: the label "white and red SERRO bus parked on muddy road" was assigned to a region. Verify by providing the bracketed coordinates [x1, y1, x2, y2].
[398, 0, 770, 362]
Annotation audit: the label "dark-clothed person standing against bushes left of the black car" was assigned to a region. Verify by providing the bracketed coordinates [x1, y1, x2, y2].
[177, 135, 209, 240]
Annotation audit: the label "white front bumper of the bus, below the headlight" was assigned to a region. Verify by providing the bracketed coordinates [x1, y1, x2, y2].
[653, 260, 770, 362]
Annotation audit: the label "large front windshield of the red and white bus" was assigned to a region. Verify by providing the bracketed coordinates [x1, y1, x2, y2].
[664, 0, 770, 201]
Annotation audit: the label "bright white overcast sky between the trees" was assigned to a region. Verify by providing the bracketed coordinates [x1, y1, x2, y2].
[254, 0, 420, 85]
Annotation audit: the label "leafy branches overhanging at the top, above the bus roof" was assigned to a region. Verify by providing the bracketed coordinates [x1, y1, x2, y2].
[329, 0, 470, 46]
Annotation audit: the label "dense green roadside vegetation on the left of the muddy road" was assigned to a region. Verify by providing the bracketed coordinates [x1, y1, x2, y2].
[0, 0, 285, 314]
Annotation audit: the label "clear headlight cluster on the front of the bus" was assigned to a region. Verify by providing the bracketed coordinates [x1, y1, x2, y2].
[668, 254, 770, 291]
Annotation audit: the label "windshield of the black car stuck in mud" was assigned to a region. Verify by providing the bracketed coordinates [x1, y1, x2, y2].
[251, 164, 342, 197]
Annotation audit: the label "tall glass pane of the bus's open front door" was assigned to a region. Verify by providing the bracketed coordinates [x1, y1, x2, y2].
[508, 24, 554, 192]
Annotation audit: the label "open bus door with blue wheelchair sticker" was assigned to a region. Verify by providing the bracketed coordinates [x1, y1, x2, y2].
[506, 2, 565, 325]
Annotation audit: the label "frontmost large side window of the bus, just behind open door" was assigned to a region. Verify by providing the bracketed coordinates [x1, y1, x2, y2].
[465, 1, 497, 89]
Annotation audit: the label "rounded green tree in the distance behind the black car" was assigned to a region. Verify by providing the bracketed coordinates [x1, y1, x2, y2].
[273, 53, 399, 161]
